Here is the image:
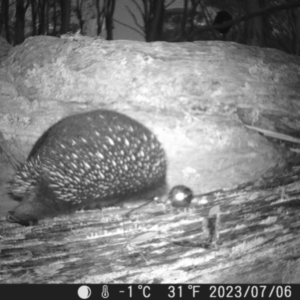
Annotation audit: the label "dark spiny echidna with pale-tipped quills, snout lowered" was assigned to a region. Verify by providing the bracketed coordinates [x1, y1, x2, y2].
[7, 110, 167, 225]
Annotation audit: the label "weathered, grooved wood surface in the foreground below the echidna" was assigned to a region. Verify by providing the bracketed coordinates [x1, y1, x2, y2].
[0, 158, 300, 283]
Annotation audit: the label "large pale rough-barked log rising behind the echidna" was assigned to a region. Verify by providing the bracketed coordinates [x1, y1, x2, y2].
[0, 36, 300, 193]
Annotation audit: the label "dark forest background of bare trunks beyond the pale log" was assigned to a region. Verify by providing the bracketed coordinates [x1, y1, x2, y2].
[0, 0, 300, 55]
